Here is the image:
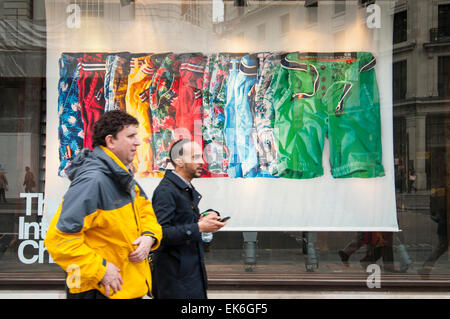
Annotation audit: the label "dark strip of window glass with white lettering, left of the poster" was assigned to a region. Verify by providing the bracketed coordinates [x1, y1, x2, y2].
[0, 1, 60, 273]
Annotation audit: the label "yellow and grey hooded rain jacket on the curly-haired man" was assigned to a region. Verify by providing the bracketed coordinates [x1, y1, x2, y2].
[45, 146, 162, 299]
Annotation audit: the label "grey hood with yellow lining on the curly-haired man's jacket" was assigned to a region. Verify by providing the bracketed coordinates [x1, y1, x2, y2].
[67, 146, 135, 193]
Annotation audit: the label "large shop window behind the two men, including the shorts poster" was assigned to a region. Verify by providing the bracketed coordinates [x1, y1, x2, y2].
[0, 0, 450, 290]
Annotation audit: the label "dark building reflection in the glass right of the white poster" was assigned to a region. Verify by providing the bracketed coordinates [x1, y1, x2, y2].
[393, 0, 450, 195]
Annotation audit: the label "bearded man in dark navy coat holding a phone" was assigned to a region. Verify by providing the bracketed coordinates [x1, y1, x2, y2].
[152, 139, 225, 299]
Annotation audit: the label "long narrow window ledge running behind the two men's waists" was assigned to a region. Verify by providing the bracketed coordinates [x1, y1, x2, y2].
[0, 272, 450, 290]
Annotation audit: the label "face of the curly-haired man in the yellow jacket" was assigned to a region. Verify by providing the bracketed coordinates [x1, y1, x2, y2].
[106, 124, 141, 166]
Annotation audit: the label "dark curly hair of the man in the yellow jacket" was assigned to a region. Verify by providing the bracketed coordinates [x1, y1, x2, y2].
[92, 110, 139, 148]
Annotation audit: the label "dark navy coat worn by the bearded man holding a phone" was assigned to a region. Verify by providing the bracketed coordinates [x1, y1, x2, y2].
[152, 170, 207, 299]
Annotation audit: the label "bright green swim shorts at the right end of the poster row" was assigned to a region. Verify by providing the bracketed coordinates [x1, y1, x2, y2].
[271, 52, 384, 178]
